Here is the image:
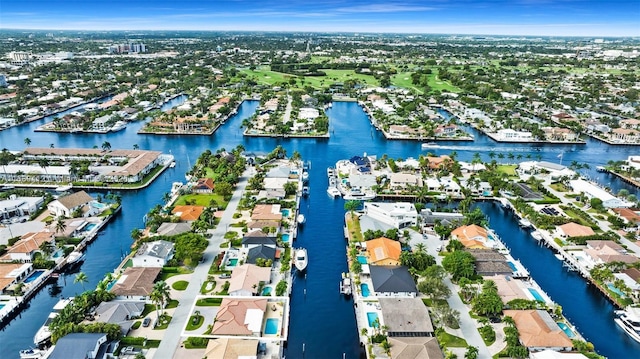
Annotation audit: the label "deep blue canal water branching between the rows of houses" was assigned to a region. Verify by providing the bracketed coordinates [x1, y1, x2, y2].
[0, 97, 640, 359]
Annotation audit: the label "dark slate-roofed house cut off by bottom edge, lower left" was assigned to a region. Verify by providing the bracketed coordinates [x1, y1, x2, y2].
[48, 333, 118, 359]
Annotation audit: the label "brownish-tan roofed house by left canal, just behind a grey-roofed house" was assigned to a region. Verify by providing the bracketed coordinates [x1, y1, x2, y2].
[111, 267, 162, 303]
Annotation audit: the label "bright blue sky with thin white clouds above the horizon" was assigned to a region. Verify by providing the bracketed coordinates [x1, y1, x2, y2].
[0, 0, 640, 36]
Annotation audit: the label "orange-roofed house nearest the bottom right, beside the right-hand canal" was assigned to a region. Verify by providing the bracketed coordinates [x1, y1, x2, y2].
[504, 310, 573, 352]
